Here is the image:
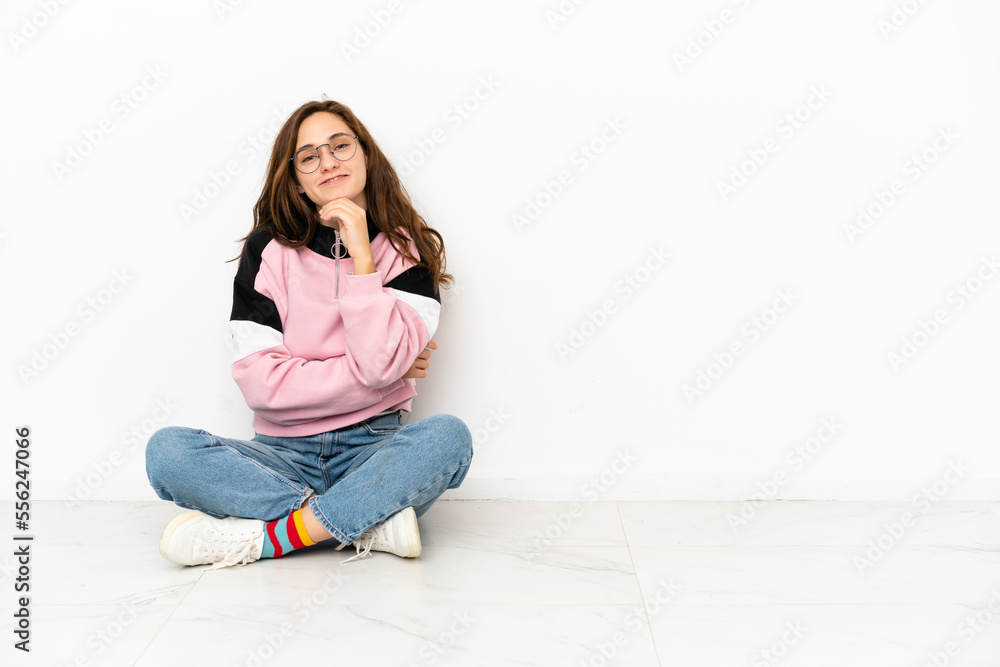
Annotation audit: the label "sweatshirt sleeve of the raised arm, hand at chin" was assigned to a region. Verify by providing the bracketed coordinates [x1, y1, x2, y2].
[340, 241, 441, 388]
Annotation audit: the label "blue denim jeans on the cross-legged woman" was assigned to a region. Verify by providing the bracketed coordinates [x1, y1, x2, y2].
[146, 410, 472, 544]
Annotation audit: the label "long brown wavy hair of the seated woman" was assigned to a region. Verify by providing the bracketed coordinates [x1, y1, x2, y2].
[228, 95, 454, 292]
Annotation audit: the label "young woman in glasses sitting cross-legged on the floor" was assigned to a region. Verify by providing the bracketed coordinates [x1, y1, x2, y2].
[146, 98, 472, 569]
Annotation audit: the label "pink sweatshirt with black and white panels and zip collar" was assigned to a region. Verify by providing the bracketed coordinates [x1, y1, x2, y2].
[230, 213, 441, 437]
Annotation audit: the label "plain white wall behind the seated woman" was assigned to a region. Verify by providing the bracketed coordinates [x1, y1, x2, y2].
[0, 0, 1000, 500]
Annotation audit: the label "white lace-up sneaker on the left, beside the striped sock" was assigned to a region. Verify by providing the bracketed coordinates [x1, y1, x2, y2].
[160, 510, 266, 570]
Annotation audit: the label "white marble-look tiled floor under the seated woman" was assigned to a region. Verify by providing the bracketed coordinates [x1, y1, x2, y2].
[0, 500, 1000, 667]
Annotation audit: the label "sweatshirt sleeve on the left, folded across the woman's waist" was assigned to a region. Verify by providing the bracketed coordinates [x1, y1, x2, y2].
[230, 230, 386, 425]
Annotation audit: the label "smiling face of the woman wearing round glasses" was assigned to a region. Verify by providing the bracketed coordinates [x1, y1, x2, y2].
[295, 111, 368, 211]
